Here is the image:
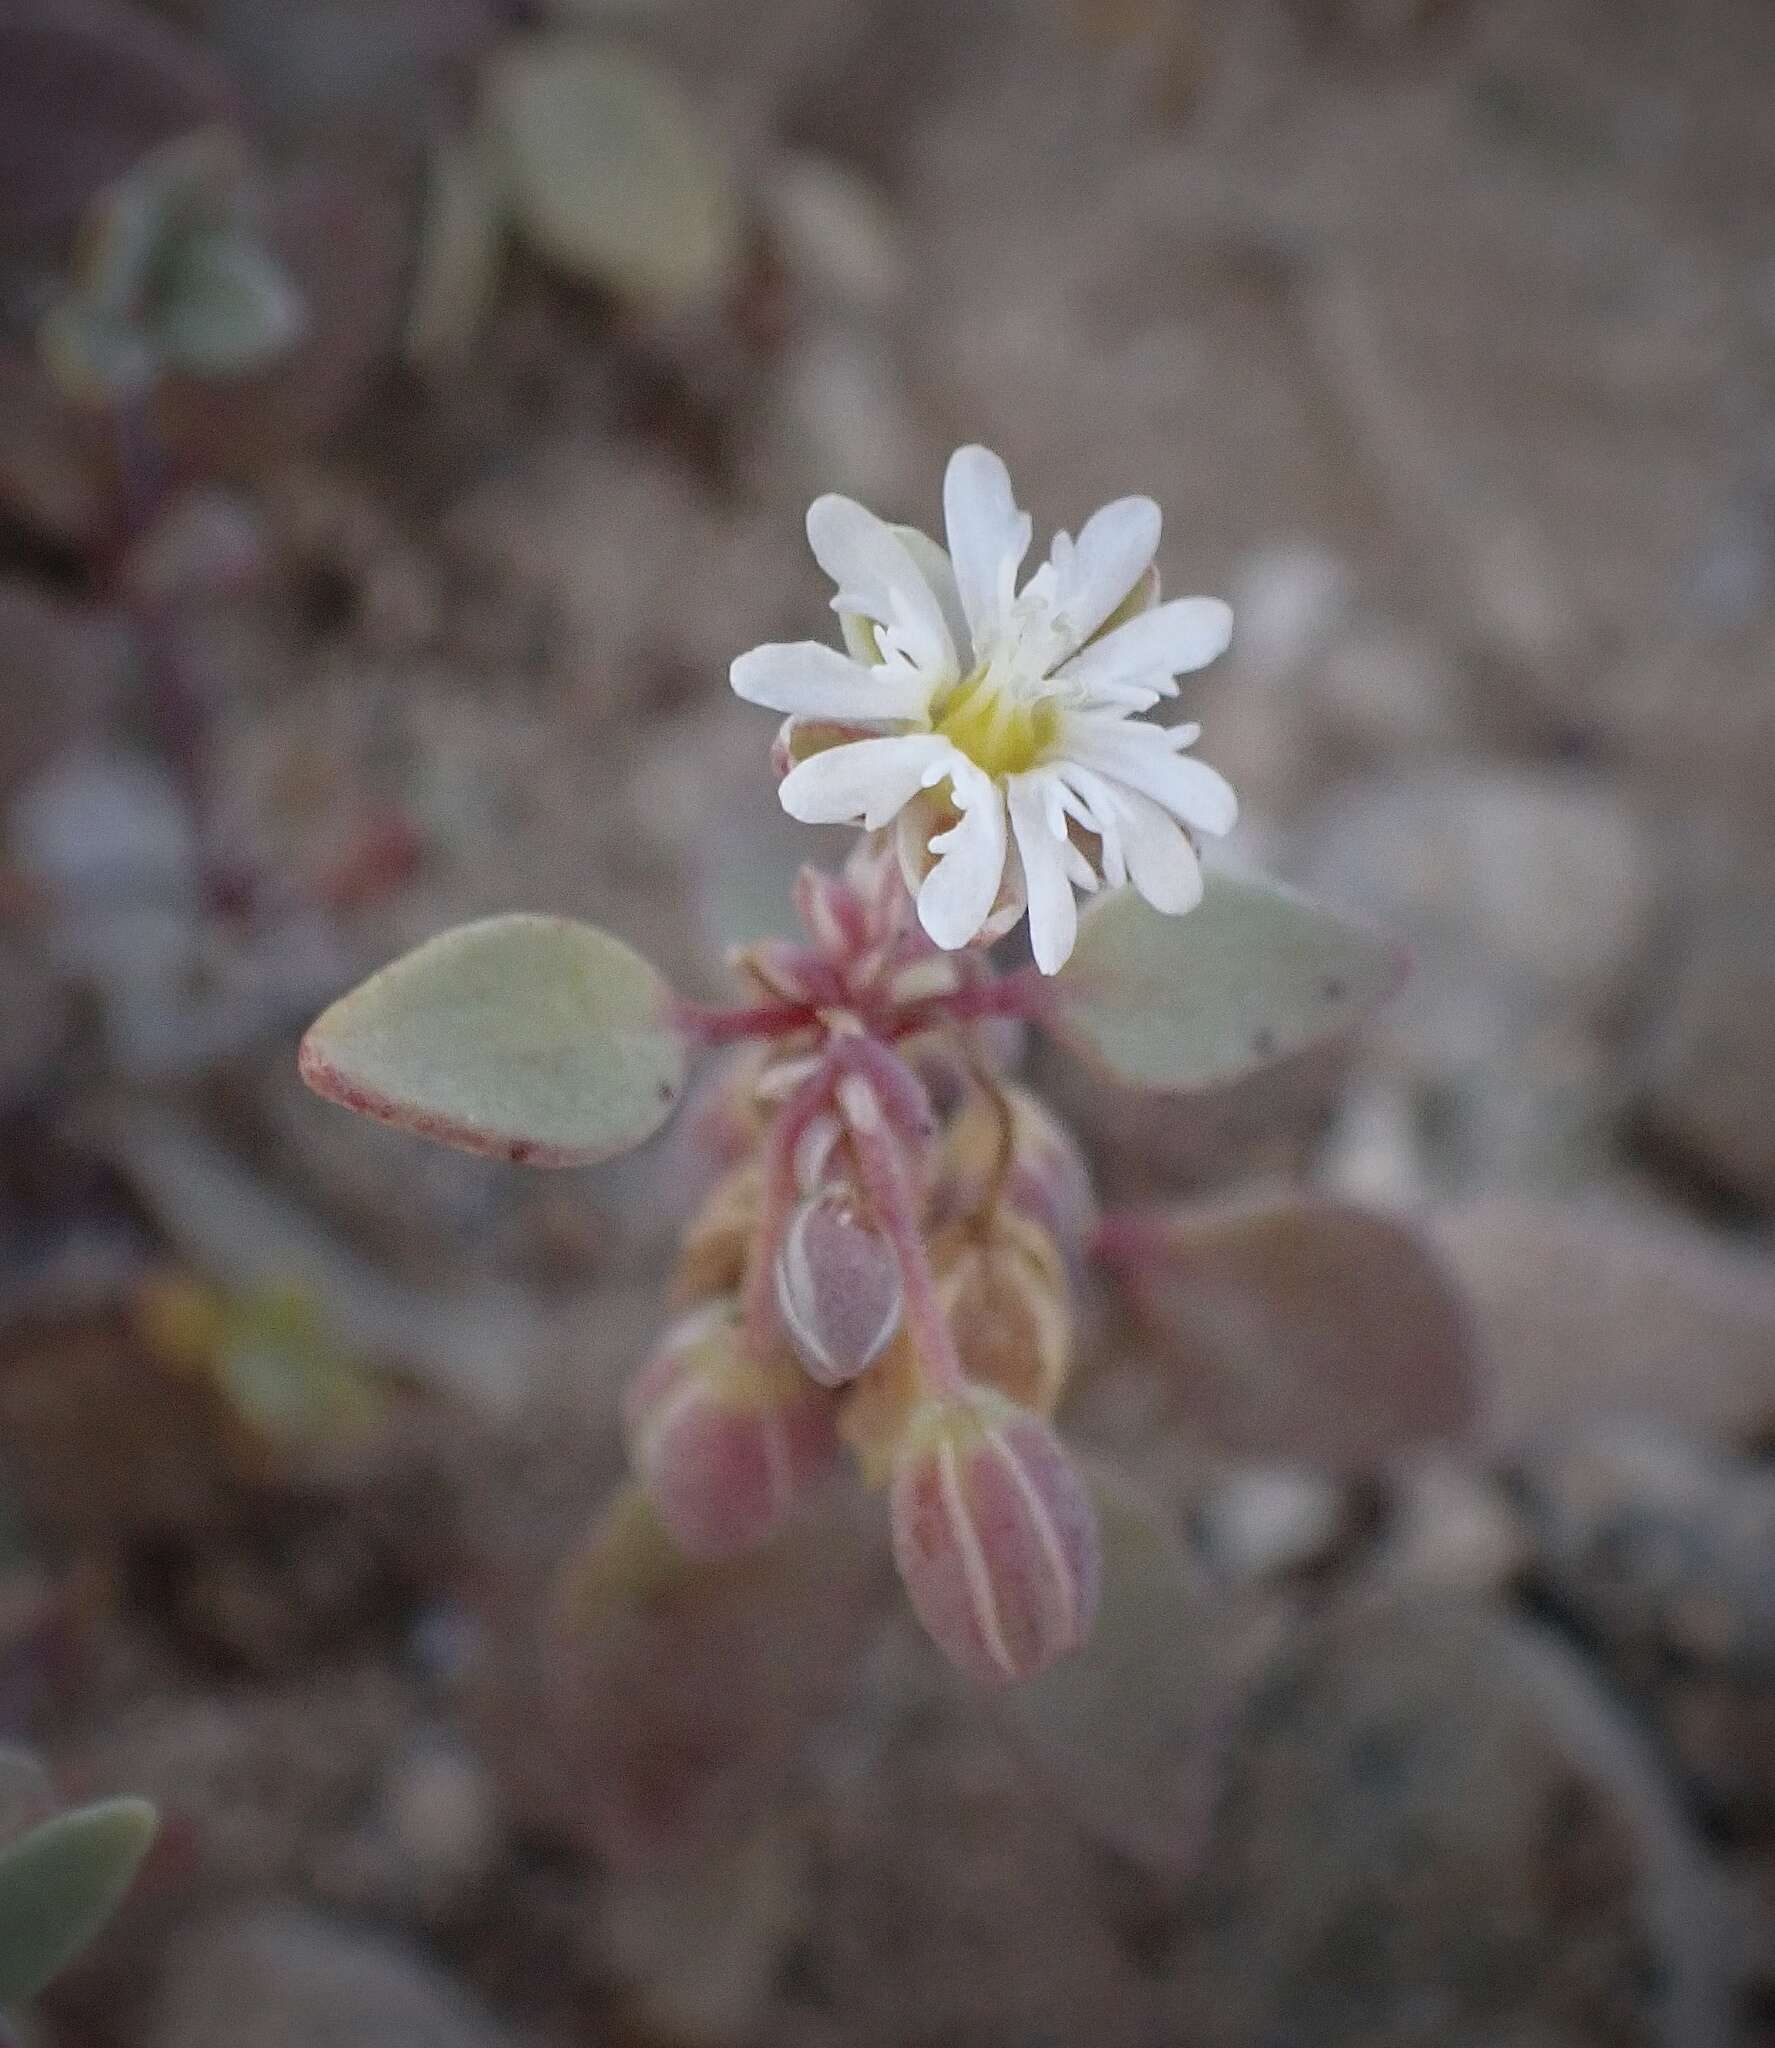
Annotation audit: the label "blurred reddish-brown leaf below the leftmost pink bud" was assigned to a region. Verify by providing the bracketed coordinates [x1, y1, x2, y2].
[549, 1485, 884, 1866]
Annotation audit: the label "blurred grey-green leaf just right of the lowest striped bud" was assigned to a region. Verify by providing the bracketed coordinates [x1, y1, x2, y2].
[993, 1468, 1232, 1870]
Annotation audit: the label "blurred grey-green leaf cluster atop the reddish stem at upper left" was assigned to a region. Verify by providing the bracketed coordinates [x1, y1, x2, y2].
[39, 129, 303, 403]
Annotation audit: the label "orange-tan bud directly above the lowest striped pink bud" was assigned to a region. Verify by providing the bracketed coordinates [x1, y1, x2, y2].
[936, 1208, 1073, 1415]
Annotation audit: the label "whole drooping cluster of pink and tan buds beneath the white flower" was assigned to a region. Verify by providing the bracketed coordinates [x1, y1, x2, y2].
[624, 842, 1097, 1683]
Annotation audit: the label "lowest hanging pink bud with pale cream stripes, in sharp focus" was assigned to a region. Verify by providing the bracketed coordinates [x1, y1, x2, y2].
[889, 1389, 1101, 1686]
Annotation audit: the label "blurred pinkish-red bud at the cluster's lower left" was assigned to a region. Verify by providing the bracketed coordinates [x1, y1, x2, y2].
[622, 1300, 837, 1556]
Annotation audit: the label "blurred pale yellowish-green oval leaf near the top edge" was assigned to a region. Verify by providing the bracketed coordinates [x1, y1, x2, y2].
[485, 35, 741, 309]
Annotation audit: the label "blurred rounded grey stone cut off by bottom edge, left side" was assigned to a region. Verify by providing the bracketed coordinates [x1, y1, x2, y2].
[149, 1905, 508, 2048]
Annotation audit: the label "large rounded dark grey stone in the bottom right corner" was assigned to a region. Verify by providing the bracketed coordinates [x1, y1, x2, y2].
[1175, 1589, 1726, 2048]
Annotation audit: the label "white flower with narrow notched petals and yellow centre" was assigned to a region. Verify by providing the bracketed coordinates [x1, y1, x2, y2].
[733, 449, 1239, 975]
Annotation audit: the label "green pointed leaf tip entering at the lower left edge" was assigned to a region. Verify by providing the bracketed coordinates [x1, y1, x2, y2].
[0, 1798, 156, 2005]
